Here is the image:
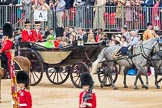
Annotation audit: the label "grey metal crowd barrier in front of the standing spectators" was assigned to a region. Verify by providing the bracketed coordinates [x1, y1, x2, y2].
[0, 6, 162, 32]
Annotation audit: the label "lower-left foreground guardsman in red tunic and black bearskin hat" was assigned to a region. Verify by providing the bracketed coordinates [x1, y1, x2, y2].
[16, 71, 32, 108]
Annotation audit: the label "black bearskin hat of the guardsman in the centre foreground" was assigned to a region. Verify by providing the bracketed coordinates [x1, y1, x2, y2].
[80, 72, 93, 86]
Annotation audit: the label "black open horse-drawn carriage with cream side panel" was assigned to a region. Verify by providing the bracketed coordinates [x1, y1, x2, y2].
[19, 42, 117, 88]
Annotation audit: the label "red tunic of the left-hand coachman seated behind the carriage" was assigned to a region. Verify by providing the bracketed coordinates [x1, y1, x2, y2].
[22, 29, 32, 42]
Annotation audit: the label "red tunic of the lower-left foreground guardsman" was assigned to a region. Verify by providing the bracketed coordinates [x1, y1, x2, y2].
[18, 89, 32, 108]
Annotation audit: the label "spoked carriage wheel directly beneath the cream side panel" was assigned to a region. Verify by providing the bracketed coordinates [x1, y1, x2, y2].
[46, 67, 70, 85]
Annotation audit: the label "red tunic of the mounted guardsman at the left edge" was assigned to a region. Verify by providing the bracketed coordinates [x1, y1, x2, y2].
[0, 39, 13, 70]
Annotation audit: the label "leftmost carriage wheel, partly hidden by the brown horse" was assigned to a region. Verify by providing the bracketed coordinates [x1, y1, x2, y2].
[22, 51, 43, 86]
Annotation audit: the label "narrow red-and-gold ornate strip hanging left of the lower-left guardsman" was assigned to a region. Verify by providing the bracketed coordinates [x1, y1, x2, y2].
[10, 50, 18, 108]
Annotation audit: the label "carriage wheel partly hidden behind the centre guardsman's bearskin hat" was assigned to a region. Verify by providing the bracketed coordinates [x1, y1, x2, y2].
[70, 61, 89, 88]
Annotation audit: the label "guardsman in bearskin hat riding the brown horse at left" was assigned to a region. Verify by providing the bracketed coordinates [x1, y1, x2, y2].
[0, 23, 13, 70]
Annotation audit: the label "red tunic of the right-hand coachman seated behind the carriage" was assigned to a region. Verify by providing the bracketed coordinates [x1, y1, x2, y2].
[31, 30, 42, 42]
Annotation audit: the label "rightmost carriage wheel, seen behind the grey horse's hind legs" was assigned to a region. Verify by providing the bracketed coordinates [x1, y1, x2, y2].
[97, 63, 118, 87]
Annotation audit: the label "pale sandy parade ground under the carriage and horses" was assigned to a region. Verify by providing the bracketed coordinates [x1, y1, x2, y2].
[0, 74, 162, 108]
